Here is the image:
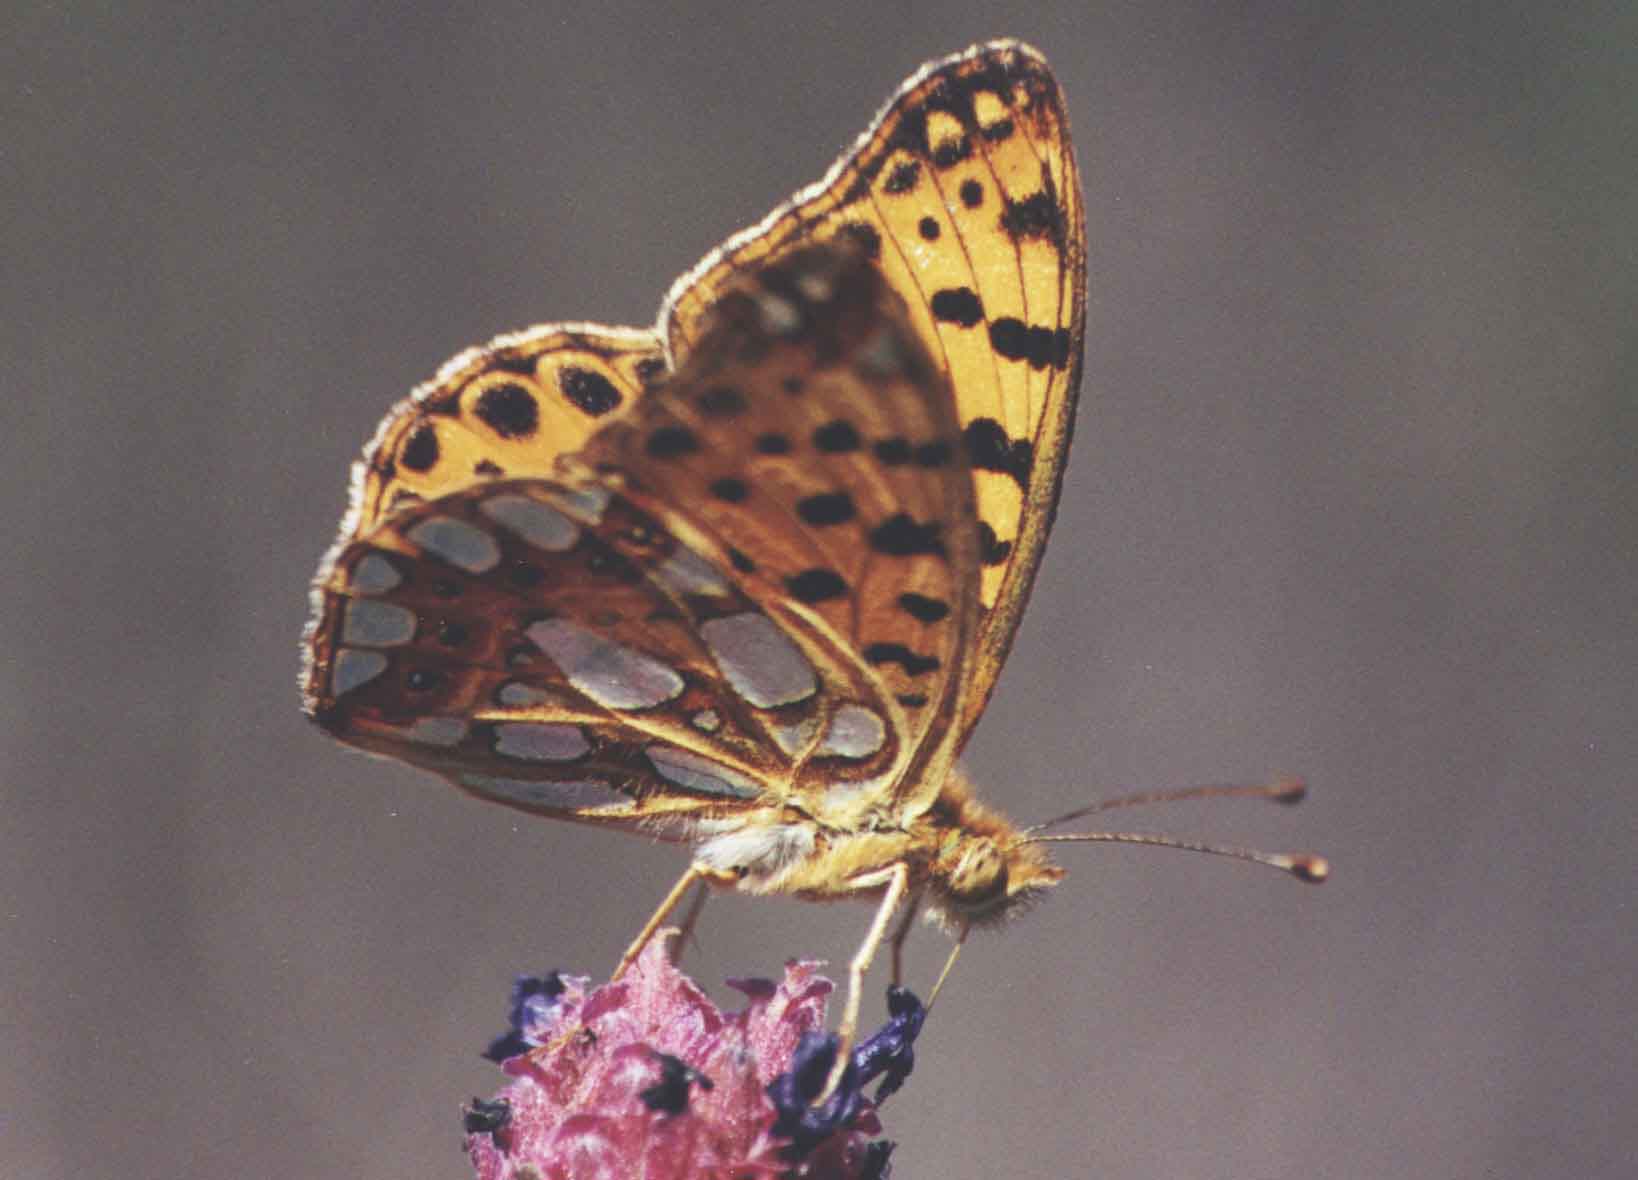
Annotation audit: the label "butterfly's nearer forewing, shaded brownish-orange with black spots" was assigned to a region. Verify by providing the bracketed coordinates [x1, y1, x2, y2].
[577, 247, 978, 815]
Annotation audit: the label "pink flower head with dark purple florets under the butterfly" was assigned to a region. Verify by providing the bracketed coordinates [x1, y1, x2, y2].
[465, 939, 924, 1180]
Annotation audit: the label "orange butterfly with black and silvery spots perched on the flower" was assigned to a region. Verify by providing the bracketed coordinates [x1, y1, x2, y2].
[303, 41, 1324, 1088]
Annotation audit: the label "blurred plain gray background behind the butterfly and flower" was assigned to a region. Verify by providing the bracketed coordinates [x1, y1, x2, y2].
[0, 0, 1638, 1180]
